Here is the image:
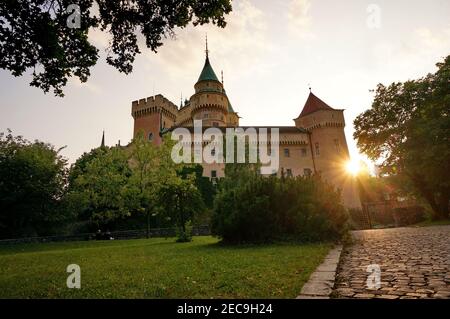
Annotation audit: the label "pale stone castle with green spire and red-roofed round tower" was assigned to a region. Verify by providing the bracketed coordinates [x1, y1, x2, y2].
[131, 43, 360, 207]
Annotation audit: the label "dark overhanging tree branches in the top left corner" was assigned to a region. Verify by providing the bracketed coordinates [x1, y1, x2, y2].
[0, 0, 231, 96]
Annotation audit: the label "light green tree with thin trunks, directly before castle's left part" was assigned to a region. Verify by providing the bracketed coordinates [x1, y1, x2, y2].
[130, 132, 202, 241]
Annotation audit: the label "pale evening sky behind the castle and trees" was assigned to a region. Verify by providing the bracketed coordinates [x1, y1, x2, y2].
[0, 0, 450, 162]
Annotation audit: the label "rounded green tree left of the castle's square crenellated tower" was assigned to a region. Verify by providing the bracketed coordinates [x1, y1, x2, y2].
[67, 148, 131, 227]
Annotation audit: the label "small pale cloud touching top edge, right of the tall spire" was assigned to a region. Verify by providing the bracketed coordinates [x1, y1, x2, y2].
[287, 0, 314, 38]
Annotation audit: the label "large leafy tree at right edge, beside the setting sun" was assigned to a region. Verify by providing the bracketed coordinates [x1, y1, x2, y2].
[354, 56, 450, 219]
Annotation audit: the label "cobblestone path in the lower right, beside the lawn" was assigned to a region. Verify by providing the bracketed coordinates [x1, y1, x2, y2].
[332, 226, 450, 299]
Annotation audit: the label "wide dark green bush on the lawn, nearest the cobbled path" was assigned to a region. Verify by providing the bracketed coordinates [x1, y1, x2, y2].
[211, 173, 347, 243]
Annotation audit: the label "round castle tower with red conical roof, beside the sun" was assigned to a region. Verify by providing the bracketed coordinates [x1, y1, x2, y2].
[294, 92, 361, 208]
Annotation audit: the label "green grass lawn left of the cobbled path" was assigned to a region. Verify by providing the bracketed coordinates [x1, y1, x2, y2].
[0, 236, 331, 298]
